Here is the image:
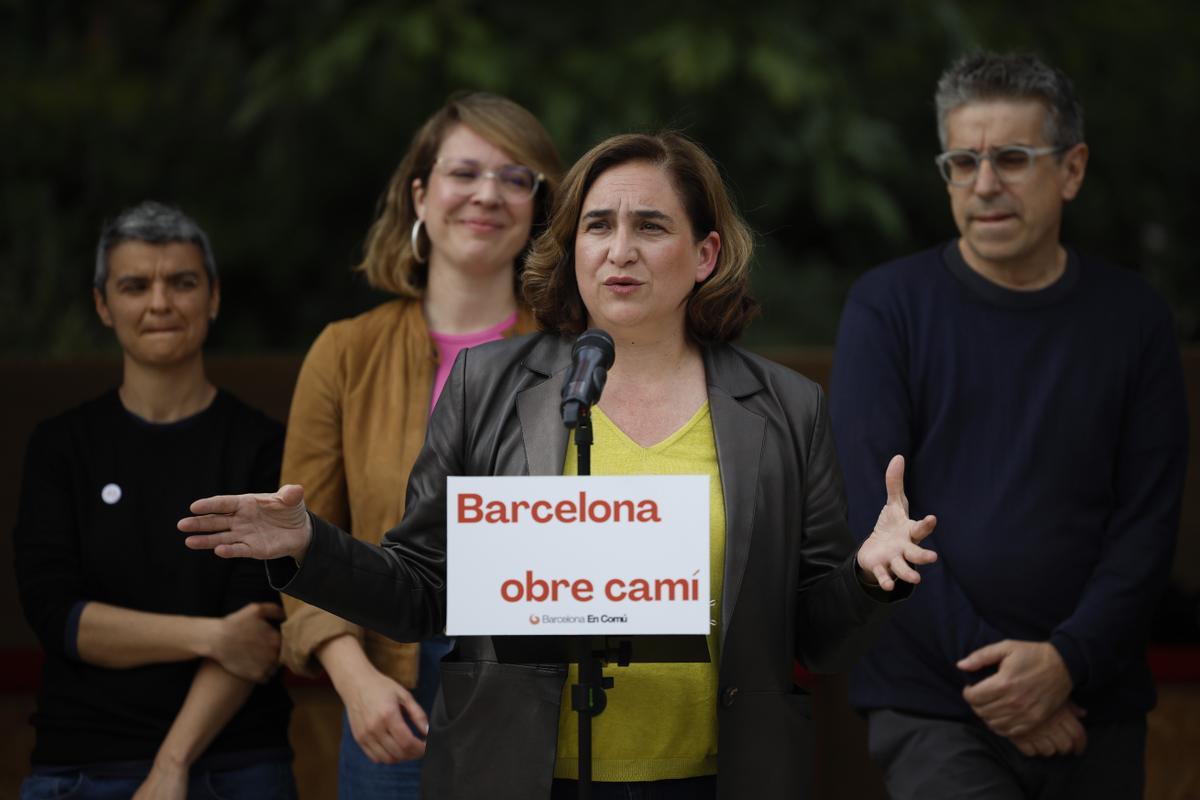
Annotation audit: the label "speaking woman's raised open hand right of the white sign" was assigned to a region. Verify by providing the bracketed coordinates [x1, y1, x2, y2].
[858, 456, 937, 591]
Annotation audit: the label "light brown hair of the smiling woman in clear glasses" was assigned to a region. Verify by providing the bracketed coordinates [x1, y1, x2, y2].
[354, 91, 563, 299]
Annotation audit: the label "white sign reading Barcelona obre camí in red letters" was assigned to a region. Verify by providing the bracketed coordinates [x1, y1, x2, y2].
[446, 475, 712, 636]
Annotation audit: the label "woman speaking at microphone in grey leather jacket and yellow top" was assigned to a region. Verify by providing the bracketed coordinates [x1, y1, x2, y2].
[180, 133, 935, 800]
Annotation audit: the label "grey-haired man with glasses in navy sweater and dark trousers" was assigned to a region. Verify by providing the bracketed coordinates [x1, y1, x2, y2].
[833, 54, 1187, 799]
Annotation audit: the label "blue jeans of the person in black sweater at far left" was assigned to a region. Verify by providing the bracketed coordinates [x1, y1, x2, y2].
[20, 762, 296, 800]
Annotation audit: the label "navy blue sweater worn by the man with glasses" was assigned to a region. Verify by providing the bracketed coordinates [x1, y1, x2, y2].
[832, 242, 1187, 722]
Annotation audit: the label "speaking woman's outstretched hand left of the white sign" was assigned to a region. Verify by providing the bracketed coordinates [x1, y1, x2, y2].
[179, 485, 312, 561]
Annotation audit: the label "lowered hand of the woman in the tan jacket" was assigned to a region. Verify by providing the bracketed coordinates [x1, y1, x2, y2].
[342, 669, 430, 764]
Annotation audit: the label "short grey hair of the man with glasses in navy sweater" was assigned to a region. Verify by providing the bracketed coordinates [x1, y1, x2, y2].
[934, 53, 1084, 150]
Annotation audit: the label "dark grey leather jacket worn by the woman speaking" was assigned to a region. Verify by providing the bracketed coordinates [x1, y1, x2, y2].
[276, 333, 906, 800]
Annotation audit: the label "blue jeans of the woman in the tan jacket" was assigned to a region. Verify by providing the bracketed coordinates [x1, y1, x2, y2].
[337, 637, 454, 800]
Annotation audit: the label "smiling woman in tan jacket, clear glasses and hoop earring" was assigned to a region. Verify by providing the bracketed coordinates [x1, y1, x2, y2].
[282, 94, 560, 800]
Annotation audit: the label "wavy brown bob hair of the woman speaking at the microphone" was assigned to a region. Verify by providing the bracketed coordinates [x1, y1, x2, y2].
[524, 132, 758, 343]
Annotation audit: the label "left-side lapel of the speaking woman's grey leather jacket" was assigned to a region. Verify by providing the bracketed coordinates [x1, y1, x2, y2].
[517, 335, 571, 475]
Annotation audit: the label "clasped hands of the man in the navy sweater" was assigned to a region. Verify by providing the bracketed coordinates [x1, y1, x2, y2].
[958, 639, 1072, 738]
